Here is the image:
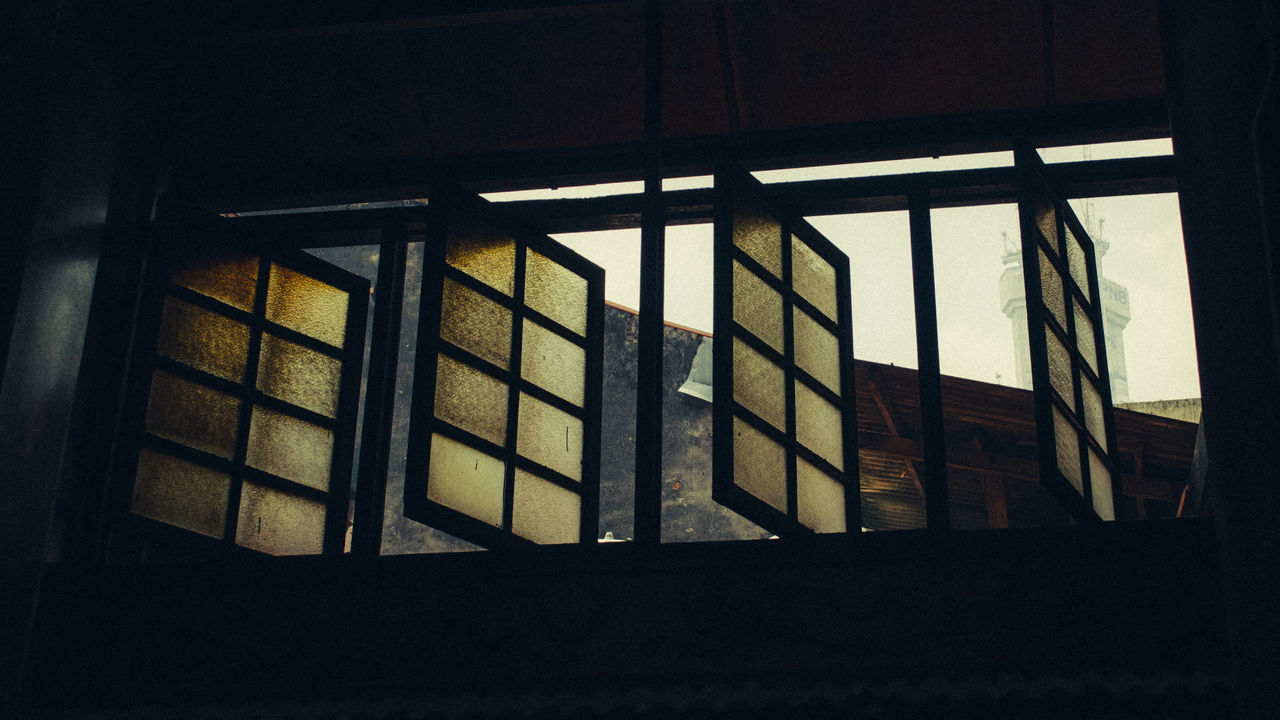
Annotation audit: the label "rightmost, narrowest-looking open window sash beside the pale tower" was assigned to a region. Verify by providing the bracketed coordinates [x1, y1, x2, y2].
[1015, 146, 1120, 523]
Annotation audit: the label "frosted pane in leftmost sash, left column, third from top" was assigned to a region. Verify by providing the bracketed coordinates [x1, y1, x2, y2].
[146, 370, 241, 460]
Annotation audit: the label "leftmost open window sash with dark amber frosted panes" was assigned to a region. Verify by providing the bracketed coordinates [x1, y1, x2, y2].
[116, 219, 370, 555]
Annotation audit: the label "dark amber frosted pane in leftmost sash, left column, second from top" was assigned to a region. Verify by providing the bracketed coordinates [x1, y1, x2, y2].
[156, 297, 248, 383]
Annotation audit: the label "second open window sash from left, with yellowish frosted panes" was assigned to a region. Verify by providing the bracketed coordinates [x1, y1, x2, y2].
[403, 187, 604, 547]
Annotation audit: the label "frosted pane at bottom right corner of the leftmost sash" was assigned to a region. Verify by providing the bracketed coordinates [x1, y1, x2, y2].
[236, 482, 325, 555]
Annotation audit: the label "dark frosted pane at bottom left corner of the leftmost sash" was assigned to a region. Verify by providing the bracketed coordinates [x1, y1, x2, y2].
[129, 450, 230, 538]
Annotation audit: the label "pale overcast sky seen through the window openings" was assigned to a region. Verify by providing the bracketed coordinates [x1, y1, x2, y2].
[486, 140, 1199, 402]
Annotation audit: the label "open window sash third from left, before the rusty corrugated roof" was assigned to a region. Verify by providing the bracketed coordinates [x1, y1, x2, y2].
[712, 168, 861, 537]
